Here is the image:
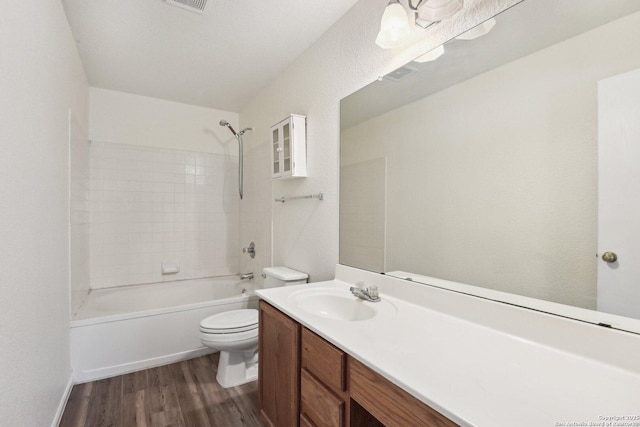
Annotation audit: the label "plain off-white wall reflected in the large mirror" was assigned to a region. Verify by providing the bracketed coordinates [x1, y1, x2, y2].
[342, 13, 640, 309]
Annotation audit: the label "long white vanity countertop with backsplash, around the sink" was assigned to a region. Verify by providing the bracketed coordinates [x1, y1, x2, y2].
[257, 272, 640, 427]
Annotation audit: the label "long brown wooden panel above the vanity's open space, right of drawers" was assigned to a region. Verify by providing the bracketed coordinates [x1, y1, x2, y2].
[349, 357, 457, 427]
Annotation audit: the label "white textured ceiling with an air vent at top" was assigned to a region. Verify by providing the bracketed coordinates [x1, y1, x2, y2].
[62, 0, 358, 112]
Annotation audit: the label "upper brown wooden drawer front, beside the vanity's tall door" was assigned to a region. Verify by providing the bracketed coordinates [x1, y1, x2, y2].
[302, 328, 346, 391]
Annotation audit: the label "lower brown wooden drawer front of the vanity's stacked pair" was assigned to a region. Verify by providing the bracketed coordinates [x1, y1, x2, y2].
[300, 369, 344, 427]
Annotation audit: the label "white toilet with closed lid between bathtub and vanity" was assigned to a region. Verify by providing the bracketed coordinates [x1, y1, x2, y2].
[200, 267, 309, 388]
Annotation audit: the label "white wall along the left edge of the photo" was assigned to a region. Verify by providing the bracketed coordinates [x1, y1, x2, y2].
[0, 0, 88, 426]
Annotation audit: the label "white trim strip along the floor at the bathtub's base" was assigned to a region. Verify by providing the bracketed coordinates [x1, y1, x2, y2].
[73, 347, 215, 384]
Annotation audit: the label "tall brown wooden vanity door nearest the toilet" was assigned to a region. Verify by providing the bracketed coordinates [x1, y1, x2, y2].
[258, 301, 300, 427]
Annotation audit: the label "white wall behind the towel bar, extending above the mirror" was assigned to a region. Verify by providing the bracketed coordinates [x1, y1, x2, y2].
[240, 0, 515, 281]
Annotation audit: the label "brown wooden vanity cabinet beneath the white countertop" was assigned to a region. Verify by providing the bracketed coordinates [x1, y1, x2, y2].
[259, 301, 457, 427]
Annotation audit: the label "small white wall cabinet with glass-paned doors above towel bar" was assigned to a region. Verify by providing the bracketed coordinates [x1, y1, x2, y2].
[271, 114, 307, 179]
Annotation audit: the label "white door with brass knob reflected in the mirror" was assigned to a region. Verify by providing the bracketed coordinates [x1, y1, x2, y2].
[597, 70, 640, 318]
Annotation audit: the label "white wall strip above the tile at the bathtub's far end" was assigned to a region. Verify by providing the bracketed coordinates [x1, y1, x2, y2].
[89, 87, 240, 156]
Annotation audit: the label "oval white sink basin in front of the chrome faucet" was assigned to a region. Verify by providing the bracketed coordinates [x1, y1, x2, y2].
[289, 288, 393, 321]
